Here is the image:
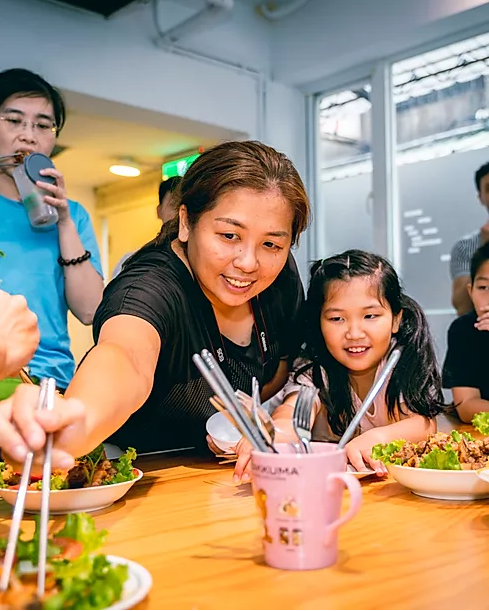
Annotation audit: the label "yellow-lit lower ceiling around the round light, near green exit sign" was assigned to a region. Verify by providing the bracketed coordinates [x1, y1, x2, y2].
[54, 92, 242, 189]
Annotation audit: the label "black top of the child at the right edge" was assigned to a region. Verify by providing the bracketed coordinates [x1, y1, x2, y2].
[443, 312, 489, 400]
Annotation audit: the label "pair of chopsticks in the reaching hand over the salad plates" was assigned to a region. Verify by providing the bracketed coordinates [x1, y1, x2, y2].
[0, 378, 56, 599]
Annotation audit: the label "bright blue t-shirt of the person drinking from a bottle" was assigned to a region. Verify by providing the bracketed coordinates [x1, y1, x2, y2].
[0, 195, 102, 388]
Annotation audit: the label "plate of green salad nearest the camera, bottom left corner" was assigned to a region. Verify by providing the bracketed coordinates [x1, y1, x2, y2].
[0, 513, 152, 610]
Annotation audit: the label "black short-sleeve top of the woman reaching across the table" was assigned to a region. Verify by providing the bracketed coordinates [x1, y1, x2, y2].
[93, 239, 304, 452]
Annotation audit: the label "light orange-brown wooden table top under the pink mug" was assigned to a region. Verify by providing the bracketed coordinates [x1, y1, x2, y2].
[1, 420, 489, 609]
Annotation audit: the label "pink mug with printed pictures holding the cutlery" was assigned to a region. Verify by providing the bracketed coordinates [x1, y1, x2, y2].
[251, 442, 362, 570]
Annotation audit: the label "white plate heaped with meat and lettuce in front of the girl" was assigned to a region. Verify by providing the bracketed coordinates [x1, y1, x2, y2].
[372, 431, 489, 501]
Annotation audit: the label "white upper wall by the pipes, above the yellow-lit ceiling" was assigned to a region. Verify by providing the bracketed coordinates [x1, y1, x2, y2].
[0, 0, 269, 135]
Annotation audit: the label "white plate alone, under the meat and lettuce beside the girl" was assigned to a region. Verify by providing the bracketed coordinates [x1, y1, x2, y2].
[387, 465, 489, 501]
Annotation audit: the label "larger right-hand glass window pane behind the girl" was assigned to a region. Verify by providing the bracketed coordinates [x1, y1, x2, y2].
[392, 29, 489, 358]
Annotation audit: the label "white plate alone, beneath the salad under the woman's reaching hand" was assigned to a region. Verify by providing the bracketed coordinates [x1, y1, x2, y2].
[0, 469, 143, 515]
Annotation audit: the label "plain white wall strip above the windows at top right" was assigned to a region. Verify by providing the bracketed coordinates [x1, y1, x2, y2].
[272, 0, 489, 90]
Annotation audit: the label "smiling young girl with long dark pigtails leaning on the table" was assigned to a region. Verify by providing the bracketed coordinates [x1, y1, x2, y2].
[266, 250, 444, 475]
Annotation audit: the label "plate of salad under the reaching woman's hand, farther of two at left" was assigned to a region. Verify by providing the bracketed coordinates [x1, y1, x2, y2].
[0, 444, 143, 515]
